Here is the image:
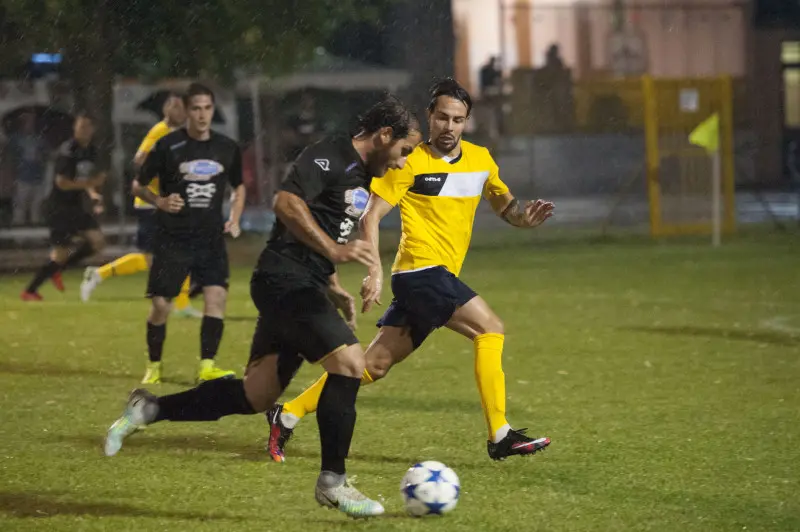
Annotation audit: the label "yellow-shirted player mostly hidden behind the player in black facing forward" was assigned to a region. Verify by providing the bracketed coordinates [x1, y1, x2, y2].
[81, 93, 203, 318]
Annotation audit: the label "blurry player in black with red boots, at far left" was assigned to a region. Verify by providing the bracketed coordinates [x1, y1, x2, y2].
[20, 113, 106, 301]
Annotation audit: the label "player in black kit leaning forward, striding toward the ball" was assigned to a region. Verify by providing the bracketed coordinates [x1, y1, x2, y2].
[105, 98, 422, 517]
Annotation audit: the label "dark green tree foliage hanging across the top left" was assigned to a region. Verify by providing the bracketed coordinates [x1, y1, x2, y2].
[2, 0, 392, 167]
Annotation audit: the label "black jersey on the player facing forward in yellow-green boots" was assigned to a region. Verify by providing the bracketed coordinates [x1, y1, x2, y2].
[139, 128, 242, 236]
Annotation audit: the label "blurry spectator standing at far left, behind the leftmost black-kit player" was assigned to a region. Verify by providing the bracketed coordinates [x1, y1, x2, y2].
[7, 112, 47, 225]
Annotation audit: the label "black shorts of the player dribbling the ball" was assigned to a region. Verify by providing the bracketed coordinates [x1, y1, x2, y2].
[250, 271, 358, 370]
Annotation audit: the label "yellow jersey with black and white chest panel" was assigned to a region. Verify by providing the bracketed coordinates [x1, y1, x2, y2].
[371, 140, 508, 275]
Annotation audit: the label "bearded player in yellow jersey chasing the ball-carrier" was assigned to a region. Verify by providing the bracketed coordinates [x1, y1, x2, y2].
[267, 79, 553, 462]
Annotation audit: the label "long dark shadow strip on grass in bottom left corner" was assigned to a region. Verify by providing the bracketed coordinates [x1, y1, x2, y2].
[0, 491, 244, 521]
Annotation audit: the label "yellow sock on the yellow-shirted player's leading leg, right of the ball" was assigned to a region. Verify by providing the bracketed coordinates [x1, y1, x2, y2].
[474, 333, 508, 441]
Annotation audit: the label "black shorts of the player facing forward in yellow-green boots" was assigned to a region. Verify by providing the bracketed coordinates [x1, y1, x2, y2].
[147, 232, 230, 299]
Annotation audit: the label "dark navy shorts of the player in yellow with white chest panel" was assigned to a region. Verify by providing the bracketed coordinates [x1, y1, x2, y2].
[378, 266, 478, 349]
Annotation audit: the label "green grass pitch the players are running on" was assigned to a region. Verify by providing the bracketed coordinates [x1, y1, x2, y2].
[0, 231, 800, 532]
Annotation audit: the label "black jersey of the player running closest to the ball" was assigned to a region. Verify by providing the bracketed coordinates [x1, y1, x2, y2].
[259, 137, 371, 280]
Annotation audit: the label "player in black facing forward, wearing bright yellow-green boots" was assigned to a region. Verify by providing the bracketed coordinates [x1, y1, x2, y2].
[131, 83, 245, 383]
